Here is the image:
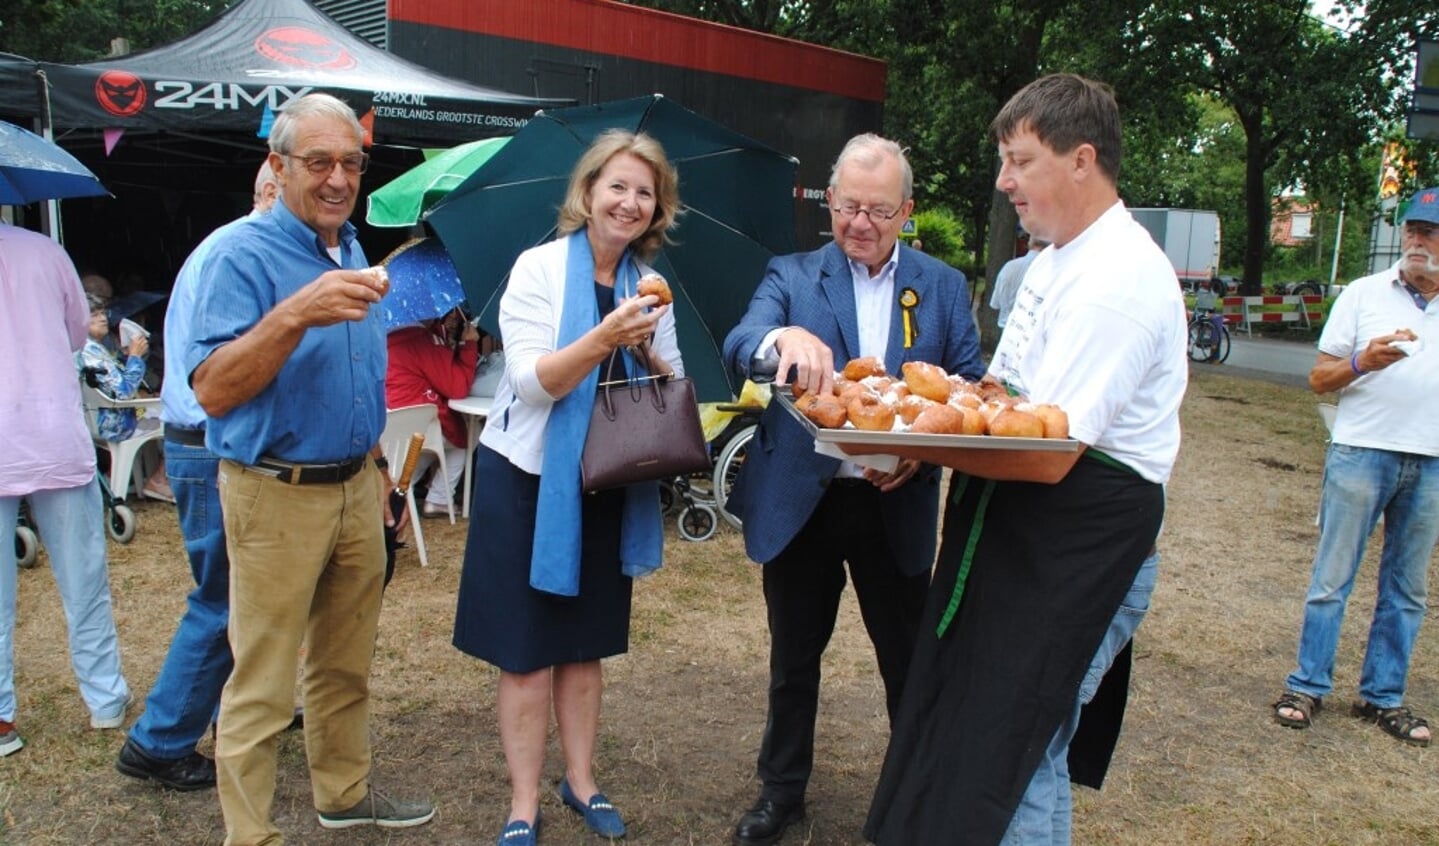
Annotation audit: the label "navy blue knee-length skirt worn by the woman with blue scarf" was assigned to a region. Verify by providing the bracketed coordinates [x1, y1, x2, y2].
[455, 445, 633, 673]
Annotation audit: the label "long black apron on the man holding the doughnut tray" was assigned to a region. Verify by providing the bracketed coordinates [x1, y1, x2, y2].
[865, 450, 1164, 846]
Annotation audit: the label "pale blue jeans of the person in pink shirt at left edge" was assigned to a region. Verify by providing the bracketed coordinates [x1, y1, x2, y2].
[0, 479, 130, 722]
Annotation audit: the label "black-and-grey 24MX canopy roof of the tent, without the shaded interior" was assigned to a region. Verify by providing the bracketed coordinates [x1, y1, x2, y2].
[0, 0, 568, 147]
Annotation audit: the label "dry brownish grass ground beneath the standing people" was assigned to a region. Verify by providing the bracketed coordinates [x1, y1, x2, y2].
[0, 368, 1439, 846]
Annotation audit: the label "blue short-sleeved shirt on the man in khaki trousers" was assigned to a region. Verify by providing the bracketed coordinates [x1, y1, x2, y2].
[184, 200, 386, 465]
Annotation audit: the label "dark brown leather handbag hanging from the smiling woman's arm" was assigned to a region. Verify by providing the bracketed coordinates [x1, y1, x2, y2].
[580, 348, 709, 494]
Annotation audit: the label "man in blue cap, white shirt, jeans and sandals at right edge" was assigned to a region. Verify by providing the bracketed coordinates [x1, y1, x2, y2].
[1274, 187, 1439, 747]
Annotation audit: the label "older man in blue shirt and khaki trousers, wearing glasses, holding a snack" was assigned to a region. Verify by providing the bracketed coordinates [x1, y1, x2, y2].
[186, 95, 435, 846]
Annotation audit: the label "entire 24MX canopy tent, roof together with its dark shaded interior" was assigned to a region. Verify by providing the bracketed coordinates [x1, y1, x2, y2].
[0, 0, 570, 289]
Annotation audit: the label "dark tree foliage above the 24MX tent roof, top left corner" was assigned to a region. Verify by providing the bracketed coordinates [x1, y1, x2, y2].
[0, 0, 236, 62]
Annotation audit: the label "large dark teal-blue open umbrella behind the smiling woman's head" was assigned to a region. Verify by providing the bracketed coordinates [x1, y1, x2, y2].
[425, 95, 797, 401]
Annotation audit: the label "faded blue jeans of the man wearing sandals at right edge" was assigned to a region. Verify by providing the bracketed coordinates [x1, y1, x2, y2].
[1285, 443, 1439, 708]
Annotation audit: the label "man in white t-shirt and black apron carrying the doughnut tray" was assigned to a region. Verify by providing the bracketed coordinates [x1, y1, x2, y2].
[865, 73, 1187, 846]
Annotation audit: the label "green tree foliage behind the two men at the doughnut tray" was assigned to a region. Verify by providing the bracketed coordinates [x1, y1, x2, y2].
[635, 0, 1439, 297]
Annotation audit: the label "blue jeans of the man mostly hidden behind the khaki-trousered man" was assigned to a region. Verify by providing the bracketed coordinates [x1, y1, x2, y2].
[130, 439, 235, 758]
